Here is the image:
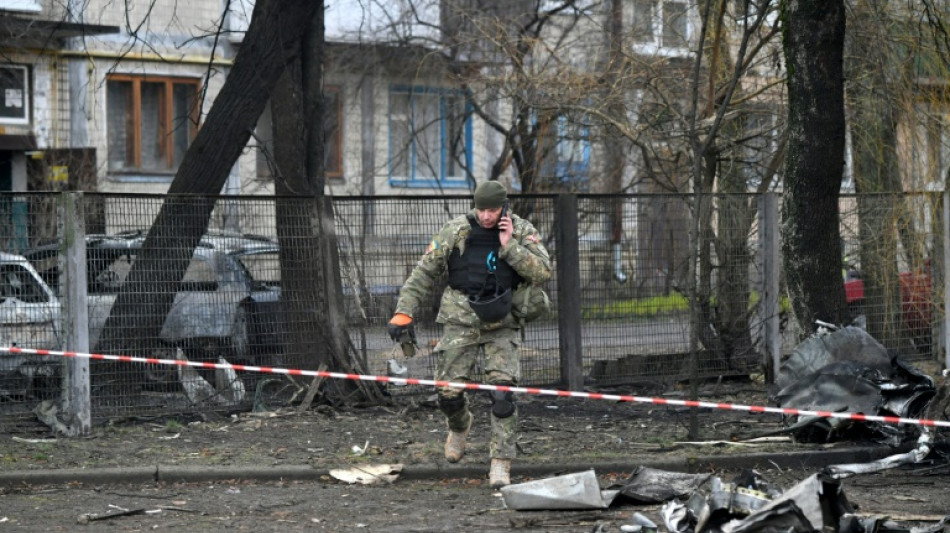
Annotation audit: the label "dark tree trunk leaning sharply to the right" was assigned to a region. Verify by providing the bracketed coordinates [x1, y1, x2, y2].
[96, 0, 318, 366]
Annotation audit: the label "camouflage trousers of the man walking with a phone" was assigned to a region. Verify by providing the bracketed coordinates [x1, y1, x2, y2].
[435, 324, 521, 459]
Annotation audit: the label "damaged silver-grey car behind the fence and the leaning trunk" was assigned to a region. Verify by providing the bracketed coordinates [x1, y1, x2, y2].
[26, 231, 280, 362]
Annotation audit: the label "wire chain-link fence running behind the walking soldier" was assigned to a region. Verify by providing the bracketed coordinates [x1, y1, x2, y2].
[0, 189, 944, 427]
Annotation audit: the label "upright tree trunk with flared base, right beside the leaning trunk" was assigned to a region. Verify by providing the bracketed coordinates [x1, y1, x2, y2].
[271, 5, 381, 400]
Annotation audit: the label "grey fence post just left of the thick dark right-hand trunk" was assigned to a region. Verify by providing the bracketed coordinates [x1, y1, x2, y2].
[759, 192, 782, 383]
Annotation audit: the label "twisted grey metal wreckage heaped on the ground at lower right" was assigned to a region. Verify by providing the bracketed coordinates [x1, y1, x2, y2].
[502, 326, 950, 533]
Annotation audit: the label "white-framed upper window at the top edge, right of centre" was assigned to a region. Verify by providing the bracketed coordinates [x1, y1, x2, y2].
[632, 0, 692, 53]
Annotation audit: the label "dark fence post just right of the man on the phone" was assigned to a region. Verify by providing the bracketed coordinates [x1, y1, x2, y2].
[555, 193, 584, 390]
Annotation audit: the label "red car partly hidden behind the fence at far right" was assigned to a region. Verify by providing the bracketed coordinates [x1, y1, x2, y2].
[844, 261, 934, 350]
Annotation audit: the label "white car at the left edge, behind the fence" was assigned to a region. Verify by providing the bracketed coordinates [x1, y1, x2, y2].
[0, 252, 62, 398]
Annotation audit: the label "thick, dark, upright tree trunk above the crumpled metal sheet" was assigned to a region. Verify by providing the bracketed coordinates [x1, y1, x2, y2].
[782, 0, 848, 333]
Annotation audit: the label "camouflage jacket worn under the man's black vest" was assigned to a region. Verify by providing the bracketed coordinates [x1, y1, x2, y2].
[396, 210, 551, 329]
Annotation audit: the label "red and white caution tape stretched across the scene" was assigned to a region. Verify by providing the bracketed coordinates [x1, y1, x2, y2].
[7, 346, 950, 428]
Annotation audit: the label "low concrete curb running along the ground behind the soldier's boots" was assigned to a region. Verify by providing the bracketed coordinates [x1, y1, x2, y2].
[0, 446, 906, 487]
